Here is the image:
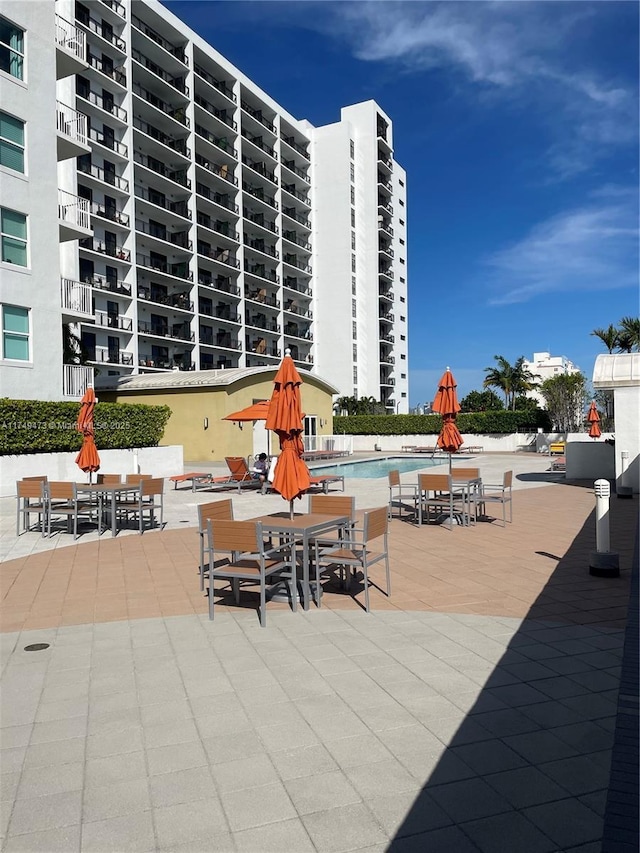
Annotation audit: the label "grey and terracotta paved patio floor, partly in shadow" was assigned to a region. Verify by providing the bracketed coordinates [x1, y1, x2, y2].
[0, 455, 637, 853]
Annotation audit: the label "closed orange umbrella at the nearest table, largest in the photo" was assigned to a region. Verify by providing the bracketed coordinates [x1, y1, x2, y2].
[266, 349, 311, 518]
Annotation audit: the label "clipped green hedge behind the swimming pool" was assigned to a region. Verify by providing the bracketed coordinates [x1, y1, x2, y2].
[333, 410, 551, 435]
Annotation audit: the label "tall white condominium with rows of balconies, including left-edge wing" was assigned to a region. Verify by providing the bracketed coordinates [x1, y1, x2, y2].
[0, 0, 408, 411]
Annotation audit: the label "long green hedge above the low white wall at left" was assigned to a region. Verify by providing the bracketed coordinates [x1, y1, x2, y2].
[0, 397, 171, 456]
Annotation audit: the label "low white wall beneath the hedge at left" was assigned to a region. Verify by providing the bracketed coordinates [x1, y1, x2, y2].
[0, 446, 183, 497]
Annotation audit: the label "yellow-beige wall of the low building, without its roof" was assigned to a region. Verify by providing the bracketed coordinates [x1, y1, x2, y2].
[99, 377, 332, 462]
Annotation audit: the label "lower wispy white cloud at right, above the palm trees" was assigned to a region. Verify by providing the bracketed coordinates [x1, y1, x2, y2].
[485, 187, 638, 305]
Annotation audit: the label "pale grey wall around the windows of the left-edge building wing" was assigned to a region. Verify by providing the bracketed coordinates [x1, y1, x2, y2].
[0, 0, 62, 400]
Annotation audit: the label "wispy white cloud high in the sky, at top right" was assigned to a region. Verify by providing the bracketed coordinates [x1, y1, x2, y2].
[330, 0, 637, 178]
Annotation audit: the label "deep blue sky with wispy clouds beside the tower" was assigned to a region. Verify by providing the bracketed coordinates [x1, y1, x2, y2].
[165, 0, 639, 406]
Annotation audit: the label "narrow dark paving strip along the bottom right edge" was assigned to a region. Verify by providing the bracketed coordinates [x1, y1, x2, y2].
[602, 512, 640, 853]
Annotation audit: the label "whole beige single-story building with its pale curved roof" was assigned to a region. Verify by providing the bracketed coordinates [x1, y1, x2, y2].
[95, 366, 337, 462]
